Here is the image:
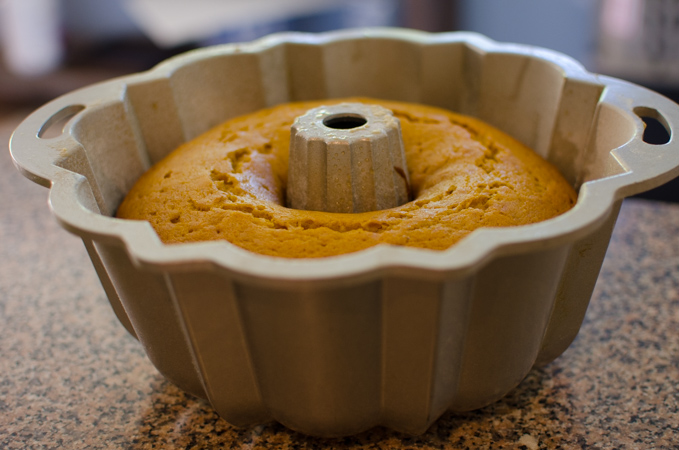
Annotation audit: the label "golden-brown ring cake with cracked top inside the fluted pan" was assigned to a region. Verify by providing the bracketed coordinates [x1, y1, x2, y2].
[117, 99, 577, 258]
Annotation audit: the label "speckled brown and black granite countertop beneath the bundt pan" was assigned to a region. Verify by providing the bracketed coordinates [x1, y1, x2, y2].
[0, 110, 679, 450]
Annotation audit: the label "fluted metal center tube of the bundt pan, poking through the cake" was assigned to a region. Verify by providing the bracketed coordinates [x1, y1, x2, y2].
[287, 103, 410, 213]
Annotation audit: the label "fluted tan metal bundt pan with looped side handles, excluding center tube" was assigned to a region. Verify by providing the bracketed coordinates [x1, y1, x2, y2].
[10, 29, 679, 436]
